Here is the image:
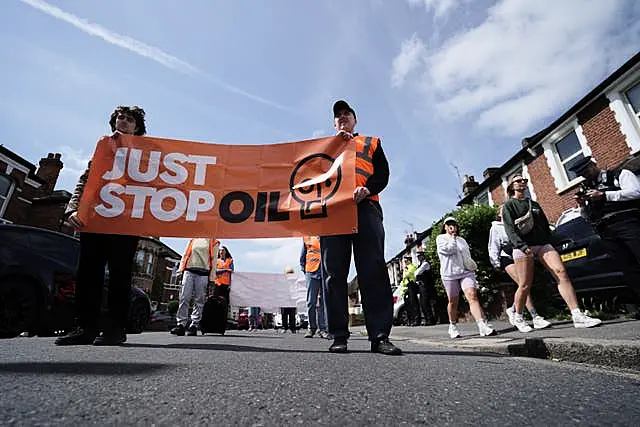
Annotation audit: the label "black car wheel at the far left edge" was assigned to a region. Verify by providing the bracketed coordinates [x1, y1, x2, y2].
[0, 277, 38, 338]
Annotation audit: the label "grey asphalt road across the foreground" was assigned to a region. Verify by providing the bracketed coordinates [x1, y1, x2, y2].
[0, 331, 640, 426]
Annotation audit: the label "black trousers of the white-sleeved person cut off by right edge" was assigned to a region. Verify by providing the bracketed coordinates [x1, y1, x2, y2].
[597, 214, 640, 298]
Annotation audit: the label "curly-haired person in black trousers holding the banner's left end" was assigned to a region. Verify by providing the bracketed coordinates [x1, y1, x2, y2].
[55, 106, 147, 345]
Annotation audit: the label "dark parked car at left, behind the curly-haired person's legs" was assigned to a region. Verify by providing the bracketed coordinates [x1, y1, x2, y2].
[0, 224, 151, 338]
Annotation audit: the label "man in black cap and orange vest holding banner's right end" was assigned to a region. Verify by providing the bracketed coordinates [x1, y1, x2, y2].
[320, 100, 402, 355]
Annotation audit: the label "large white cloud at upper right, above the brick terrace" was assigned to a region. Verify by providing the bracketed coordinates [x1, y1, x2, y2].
[394, 0, 639, 136]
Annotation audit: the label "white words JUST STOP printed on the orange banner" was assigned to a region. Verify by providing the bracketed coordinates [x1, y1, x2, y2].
[95, 147, 217, 222]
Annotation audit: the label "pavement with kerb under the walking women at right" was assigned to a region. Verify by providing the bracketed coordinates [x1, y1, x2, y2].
[364, 318, 640, 372]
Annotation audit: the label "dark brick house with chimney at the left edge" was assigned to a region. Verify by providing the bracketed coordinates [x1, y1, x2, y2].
[0, 145, 71, 233]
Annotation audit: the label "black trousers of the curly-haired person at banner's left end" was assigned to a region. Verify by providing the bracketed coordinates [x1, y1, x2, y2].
[76, 233, 138, 331]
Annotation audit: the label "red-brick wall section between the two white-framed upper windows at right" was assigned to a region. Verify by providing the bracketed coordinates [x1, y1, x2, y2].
[578, 95, 631, 169]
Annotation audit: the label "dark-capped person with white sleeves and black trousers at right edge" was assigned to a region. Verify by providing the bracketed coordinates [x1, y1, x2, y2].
[570, 156, 640, 297]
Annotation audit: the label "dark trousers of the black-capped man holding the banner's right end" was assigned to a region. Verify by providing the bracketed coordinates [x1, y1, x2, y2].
[320, 200, 393, 341]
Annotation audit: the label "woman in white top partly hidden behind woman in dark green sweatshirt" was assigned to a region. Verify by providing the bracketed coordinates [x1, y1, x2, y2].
[489, 205, 551, 332]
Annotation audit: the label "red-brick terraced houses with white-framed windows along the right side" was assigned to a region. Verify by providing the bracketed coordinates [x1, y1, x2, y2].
[458, 53, 640, 223]
